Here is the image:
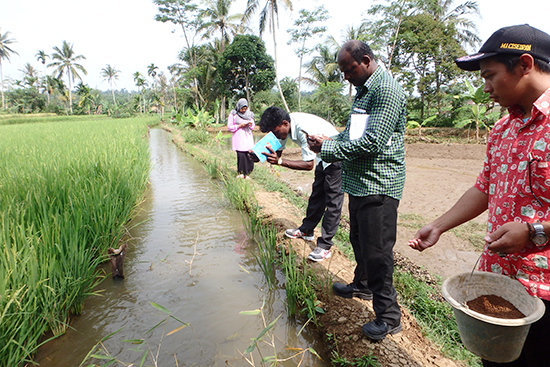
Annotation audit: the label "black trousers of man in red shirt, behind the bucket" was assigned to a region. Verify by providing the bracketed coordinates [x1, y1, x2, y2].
[481, 300, 550, 367]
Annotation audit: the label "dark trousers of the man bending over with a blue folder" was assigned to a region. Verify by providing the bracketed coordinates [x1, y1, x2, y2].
[300, 162, 344, 250]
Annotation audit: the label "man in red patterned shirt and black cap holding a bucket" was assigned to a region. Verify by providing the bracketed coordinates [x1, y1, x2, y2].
[409, 24, 550, 367]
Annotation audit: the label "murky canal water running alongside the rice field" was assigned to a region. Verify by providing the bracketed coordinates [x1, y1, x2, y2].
[35, 129, 329, 367]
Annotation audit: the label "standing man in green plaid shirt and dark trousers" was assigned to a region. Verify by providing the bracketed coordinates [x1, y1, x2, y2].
[309, 41, 406, 340]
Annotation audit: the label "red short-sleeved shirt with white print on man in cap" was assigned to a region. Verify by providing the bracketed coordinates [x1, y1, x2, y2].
[475, 89, 550, 300]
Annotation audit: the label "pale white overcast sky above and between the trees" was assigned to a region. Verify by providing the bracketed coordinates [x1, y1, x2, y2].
[0, 0, 550, 90]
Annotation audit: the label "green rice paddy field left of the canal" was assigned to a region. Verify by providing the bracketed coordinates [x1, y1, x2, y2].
[0, 115, 158, 367]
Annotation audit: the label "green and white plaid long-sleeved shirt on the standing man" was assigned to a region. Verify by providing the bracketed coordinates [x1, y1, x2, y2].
[321, 67, 407, 200]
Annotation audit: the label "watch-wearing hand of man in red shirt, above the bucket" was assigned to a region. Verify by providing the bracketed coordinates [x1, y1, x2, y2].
[485, 222, 531, 254]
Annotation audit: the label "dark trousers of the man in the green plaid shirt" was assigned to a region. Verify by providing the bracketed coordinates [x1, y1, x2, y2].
[349, 195, 401, 326]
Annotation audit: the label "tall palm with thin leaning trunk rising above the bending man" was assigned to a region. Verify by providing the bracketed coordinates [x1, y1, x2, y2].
[243, 0, 292, 112]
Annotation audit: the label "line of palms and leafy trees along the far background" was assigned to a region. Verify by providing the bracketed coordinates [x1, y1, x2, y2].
[0, 0, 500, 132]
